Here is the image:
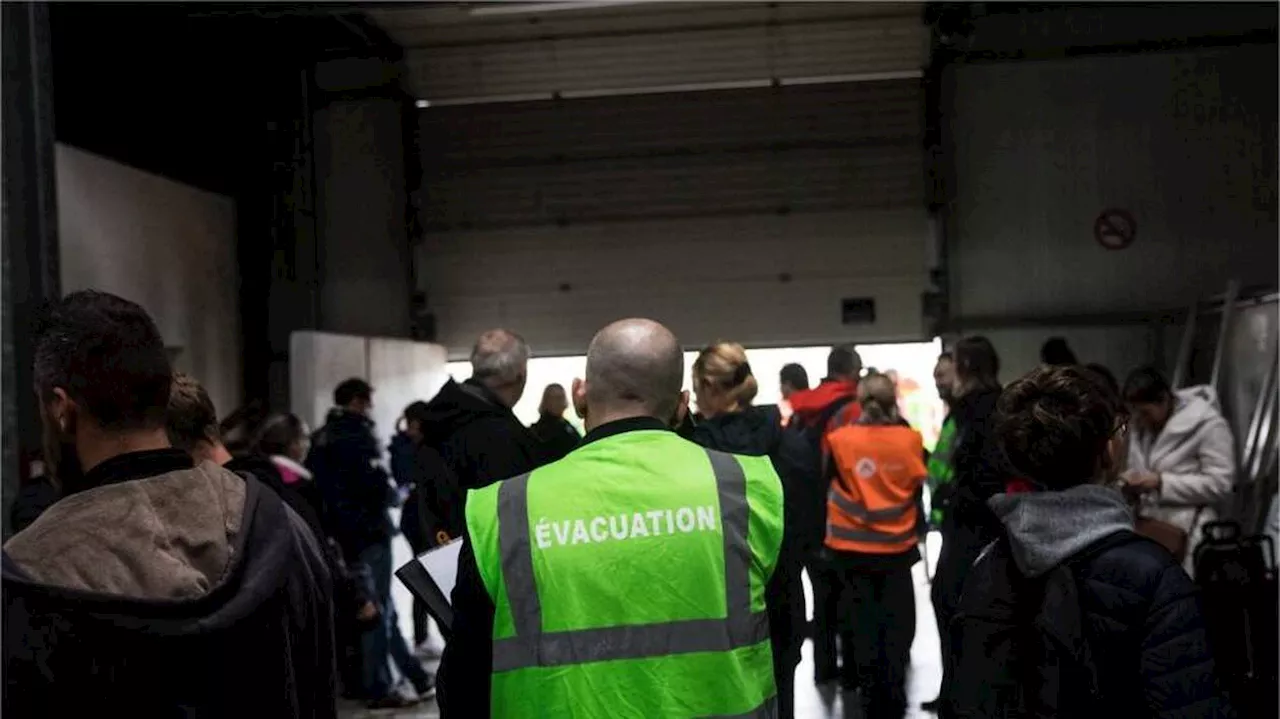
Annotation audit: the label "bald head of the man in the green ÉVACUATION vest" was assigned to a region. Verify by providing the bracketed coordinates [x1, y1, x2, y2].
[586, 320, 685, 421]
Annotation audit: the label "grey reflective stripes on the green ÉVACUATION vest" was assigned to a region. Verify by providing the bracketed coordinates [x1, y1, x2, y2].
[493, 450, 777, 670]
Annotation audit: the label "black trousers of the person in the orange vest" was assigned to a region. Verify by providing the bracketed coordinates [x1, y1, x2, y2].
[840, 567, 915, 719]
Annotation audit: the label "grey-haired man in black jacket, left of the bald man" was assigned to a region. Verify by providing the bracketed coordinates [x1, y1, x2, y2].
[413, 329, 541, 537]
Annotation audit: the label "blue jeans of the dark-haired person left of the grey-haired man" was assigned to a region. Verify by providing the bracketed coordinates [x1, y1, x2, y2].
[360, 540, 431, 700]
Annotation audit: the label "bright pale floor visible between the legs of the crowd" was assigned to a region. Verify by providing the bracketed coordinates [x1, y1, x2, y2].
[339, 535, 942, 719]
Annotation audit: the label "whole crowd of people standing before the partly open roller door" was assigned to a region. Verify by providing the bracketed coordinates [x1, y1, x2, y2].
[3, 292, 1249, 719]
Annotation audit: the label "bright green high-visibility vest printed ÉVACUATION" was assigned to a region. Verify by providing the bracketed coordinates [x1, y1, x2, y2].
[466, 430, 782, 719]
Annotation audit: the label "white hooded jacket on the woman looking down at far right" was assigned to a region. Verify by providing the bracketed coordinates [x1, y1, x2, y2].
[1129, 385, 1235, 573]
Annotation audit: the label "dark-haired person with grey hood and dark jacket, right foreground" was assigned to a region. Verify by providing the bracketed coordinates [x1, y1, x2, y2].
[950, 366, 1230, 719]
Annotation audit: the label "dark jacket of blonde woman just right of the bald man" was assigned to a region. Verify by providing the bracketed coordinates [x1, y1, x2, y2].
[692, 407, 817, 670]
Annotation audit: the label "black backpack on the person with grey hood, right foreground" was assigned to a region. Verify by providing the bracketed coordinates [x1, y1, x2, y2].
[948, 531, 1149, 716]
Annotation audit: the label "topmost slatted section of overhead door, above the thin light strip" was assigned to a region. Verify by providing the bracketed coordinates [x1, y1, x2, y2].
[369, 3, 928, 102]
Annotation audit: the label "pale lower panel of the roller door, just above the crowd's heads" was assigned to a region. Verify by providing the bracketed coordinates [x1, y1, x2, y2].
[422, 210, 928, 357]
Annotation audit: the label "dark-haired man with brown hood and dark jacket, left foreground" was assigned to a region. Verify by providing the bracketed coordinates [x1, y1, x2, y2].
[0, 292, 337, 718]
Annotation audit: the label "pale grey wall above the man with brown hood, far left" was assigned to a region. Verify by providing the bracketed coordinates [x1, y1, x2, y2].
[56, 145, 242, 415]
